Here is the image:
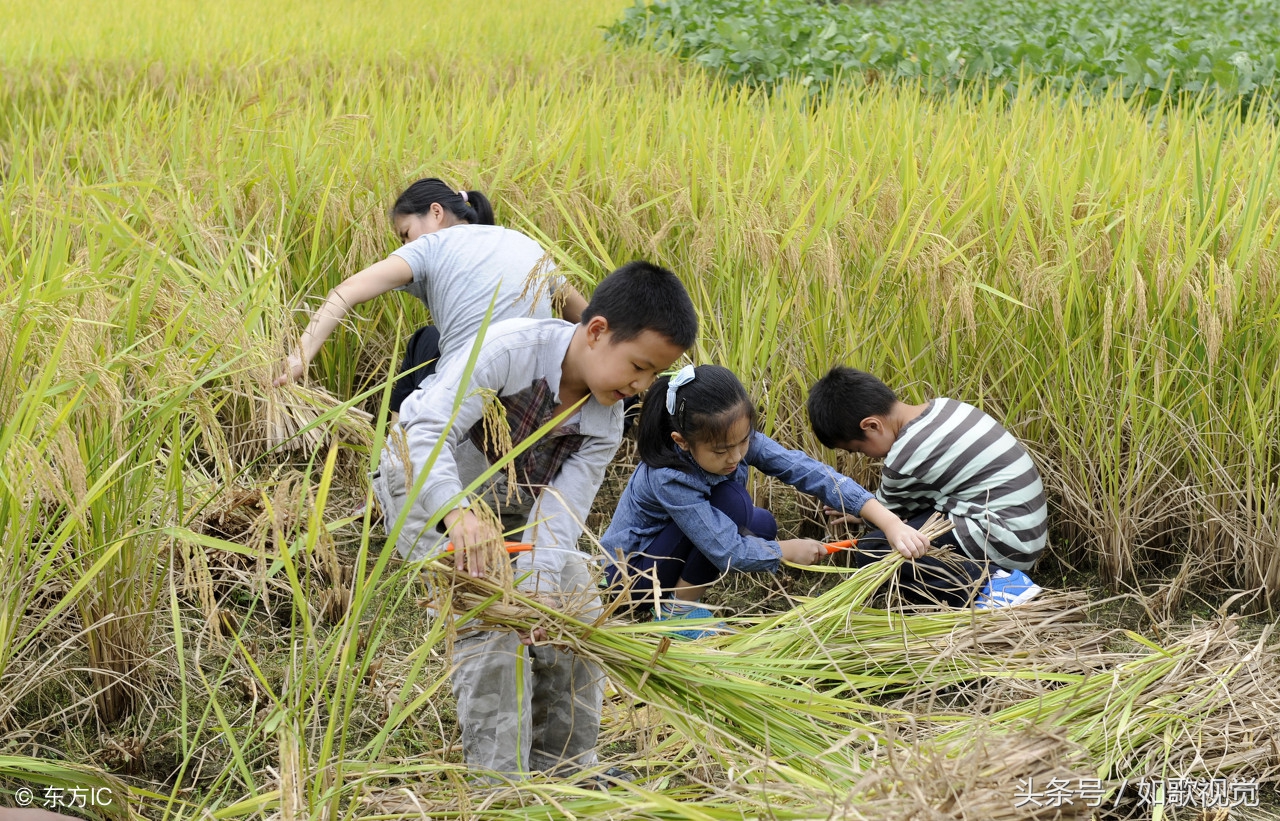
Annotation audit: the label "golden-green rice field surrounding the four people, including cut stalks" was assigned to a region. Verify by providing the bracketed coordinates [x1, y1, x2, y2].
[0, 0, 1280, 821]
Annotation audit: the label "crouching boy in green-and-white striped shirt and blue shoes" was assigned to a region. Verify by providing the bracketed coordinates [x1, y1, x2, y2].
[809, 368, 1047, 607]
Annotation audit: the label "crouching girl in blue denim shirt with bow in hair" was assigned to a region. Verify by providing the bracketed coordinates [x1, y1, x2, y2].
[600, 365, 928, 638]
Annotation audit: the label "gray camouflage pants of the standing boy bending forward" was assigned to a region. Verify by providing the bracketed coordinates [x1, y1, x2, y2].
[372, 435, 604, 779]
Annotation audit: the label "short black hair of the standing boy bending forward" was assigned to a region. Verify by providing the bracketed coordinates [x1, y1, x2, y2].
[581, 260, 698, 350]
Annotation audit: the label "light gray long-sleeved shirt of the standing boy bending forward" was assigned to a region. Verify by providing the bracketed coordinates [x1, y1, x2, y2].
[399, 319, 622, 589]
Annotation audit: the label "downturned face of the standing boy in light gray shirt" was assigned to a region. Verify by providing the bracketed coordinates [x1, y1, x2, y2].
[582, 316, 685, 405]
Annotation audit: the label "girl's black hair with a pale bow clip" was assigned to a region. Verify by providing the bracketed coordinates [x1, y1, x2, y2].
[636, 365, 755, 470]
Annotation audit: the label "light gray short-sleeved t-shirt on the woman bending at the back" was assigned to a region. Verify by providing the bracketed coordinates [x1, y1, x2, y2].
[392, 223, 561, 370]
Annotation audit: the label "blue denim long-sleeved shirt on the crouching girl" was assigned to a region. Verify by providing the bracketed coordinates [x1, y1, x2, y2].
[600, 432, 872, 573]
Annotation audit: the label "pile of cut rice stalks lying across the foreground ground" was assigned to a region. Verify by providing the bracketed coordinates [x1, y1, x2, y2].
[435, 548, 1280, 820]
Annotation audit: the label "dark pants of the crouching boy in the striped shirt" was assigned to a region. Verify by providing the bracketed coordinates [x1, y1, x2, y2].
[854, 511, 988, 607]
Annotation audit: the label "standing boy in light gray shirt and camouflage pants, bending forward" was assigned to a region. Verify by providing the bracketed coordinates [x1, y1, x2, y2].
[374, 263, 698, 779]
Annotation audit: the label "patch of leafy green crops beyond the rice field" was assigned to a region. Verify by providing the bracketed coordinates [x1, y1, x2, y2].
[608, 0, 1280, 100]
